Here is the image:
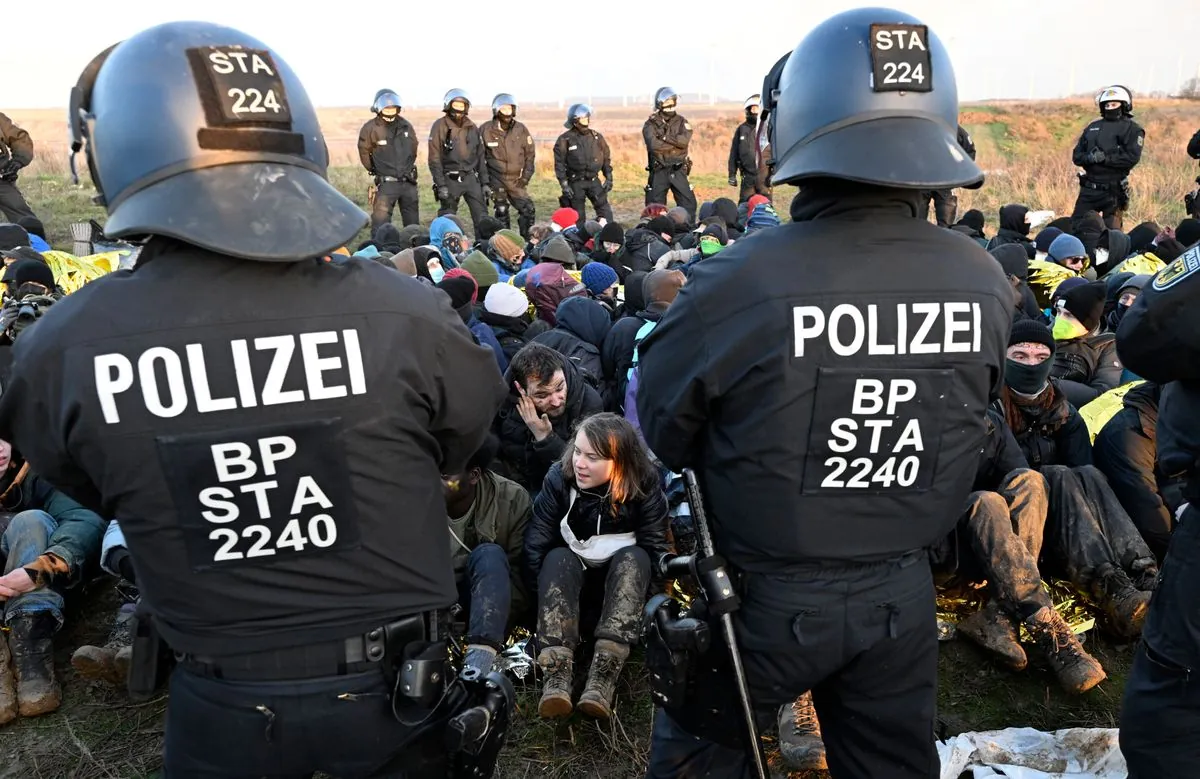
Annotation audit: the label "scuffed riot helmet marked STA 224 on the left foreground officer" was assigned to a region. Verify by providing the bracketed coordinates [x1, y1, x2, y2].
[67, 22, 367, 262]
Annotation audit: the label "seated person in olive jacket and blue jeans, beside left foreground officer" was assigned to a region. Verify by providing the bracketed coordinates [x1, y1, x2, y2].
[442, 436, 532, 676]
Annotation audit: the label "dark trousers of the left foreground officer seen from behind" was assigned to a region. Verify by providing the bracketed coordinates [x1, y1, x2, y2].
[163, 666, 448, 779]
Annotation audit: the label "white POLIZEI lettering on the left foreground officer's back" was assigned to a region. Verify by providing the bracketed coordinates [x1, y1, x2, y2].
[94, 330, 367, 425]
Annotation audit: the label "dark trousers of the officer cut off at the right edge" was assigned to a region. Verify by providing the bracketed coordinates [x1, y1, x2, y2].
[1121, 507, 1200, 779]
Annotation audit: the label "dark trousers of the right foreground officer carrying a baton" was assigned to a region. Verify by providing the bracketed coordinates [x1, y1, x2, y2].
[647, 551, 940, 779]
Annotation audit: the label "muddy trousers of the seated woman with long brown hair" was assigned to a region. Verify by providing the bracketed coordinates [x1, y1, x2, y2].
[538, 546, 650, 649]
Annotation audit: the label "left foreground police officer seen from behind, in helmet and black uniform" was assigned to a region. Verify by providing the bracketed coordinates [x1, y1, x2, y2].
[0, 22, 504, 779]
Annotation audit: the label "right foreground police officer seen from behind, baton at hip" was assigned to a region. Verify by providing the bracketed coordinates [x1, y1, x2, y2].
[638, 8, 1012, 779]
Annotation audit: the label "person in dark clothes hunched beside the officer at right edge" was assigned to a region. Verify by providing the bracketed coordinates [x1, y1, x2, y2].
[1092, 382, 1182, 562]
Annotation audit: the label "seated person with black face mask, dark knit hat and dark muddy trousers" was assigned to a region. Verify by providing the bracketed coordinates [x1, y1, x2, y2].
[1000, 322, 1158, 637]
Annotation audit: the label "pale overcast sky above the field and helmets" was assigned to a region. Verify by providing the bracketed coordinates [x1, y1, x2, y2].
[0, 0, 1200, 110]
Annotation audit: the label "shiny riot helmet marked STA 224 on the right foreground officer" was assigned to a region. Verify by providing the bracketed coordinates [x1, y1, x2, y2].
[770, 8, 983, 190]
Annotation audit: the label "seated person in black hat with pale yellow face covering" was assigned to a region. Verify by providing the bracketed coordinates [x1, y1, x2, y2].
[1050, 281, 1124, 408]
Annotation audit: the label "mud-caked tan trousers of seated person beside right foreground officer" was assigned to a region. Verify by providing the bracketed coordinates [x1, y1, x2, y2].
[955, 469, 1052, 621]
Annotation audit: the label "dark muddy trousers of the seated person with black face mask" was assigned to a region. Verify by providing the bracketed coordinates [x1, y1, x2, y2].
[1032, 466, 1154, 589]
